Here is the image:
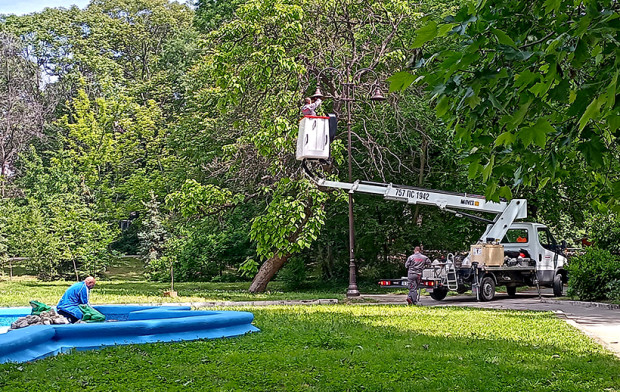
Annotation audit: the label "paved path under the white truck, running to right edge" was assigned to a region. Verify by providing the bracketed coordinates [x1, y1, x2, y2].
[361, 289, 620, 357]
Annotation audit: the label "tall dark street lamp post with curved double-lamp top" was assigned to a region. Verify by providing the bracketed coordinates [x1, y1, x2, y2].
[315, 67, 385, 297]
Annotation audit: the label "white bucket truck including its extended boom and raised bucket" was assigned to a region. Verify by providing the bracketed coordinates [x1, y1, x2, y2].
[297, 118, 568, 301]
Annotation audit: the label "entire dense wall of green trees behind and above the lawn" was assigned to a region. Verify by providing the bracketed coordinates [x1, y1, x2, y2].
[0, 0, 620, 292]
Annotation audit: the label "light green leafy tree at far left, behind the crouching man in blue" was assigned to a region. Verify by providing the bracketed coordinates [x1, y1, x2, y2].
[2, 145, 117, 279]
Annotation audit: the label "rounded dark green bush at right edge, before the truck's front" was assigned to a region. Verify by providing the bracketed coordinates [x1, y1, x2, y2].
[568, 248, 620, 301]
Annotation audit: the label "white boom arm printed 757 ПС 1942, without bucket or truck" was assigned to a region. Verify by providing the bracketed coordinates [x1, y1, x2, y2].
[311, 176, 527, 242]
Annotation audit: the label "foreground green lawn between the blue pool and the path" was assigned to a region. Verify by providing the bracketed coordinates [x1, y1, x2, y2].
[0, 305, 620, 391]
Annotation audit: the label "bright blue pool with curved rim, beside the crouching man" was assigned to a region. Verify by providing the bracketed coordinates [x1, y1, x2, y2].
[0, 305, 259, 363]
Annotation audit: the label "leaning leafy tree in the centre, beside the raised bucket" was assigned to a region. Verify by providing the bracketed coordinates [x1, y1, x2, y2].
[172, 0, 438, 291]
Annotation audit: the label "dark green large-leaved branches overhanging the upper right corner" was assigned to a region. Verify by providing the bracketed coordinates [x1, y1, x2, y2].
[392, 0, 620, 211]
